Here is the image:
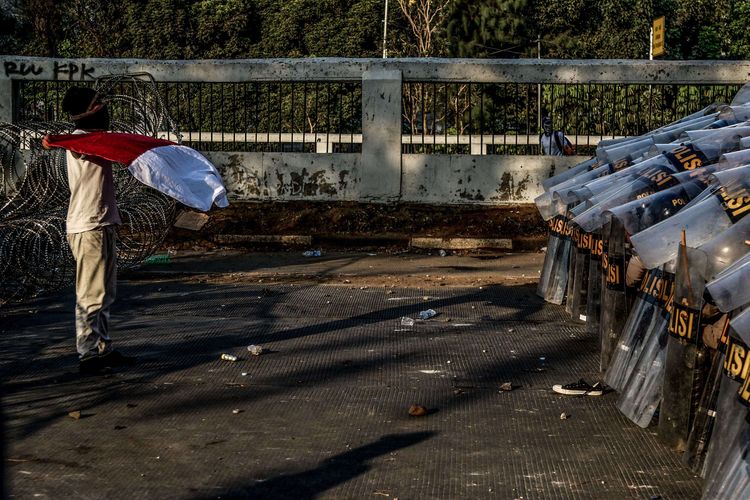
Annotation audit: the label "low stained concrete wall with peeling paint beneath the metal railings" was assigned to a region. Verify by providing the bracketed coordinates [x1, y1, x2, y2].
[207, 152, 585, 205]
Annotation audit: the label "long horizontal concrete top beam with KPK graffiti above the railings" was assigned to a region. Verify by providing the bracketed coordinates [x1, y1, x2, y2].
[5, 55, 750, 84]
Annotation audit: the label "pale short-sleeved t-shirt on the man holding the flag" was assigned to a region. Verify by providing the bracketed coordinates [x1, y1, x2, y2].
[65, 130, 122, 234]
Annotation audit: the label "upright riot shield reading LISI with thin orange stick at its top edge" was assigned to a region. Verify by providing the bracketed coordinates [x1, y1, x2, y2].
[658, 245, 707, 452]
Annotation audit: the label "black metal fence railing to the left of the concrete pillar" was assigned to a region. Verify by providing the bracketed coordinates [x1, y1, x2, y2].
[17, 81, 362, 153]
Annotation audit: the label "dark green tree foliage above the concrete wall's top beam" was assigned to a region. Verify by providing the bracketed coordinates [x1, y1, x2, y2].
[0, 0, 750, 59]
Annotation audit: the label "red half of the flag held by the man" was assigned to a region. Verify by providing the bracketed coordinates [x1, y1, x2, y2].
[46, 132, 175, 165]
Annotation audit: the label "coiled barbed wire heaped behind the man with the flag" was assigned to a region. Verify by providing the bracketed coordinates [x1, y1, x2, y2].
[0, 73, 179, 306]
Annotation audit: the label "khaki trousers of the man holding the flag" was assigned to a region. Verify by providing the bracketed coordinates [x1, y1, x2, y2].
[68, 226, 117, 357]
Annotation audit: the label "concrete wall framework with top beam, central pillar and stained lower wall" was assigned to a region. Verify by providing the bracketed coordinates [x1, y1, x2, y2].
[0, 56, 750, 204]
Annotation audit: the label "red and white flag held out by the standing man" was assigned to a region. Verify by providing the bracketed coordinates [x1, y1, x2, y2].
[44, 132, 229, 212]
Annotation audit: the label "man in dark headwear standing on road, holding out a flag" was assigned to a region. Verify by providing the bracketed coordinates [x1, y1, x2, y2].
[42, 87, 135, 374]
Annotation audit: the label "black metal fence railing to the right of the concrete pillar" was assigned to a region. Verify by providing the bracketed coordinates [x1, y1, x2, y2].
[402, 82, 740, 155]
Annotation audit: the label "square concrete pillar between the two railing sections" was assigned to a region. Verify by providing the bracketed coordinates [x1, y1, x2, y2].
[360, 69, 401, 203]
